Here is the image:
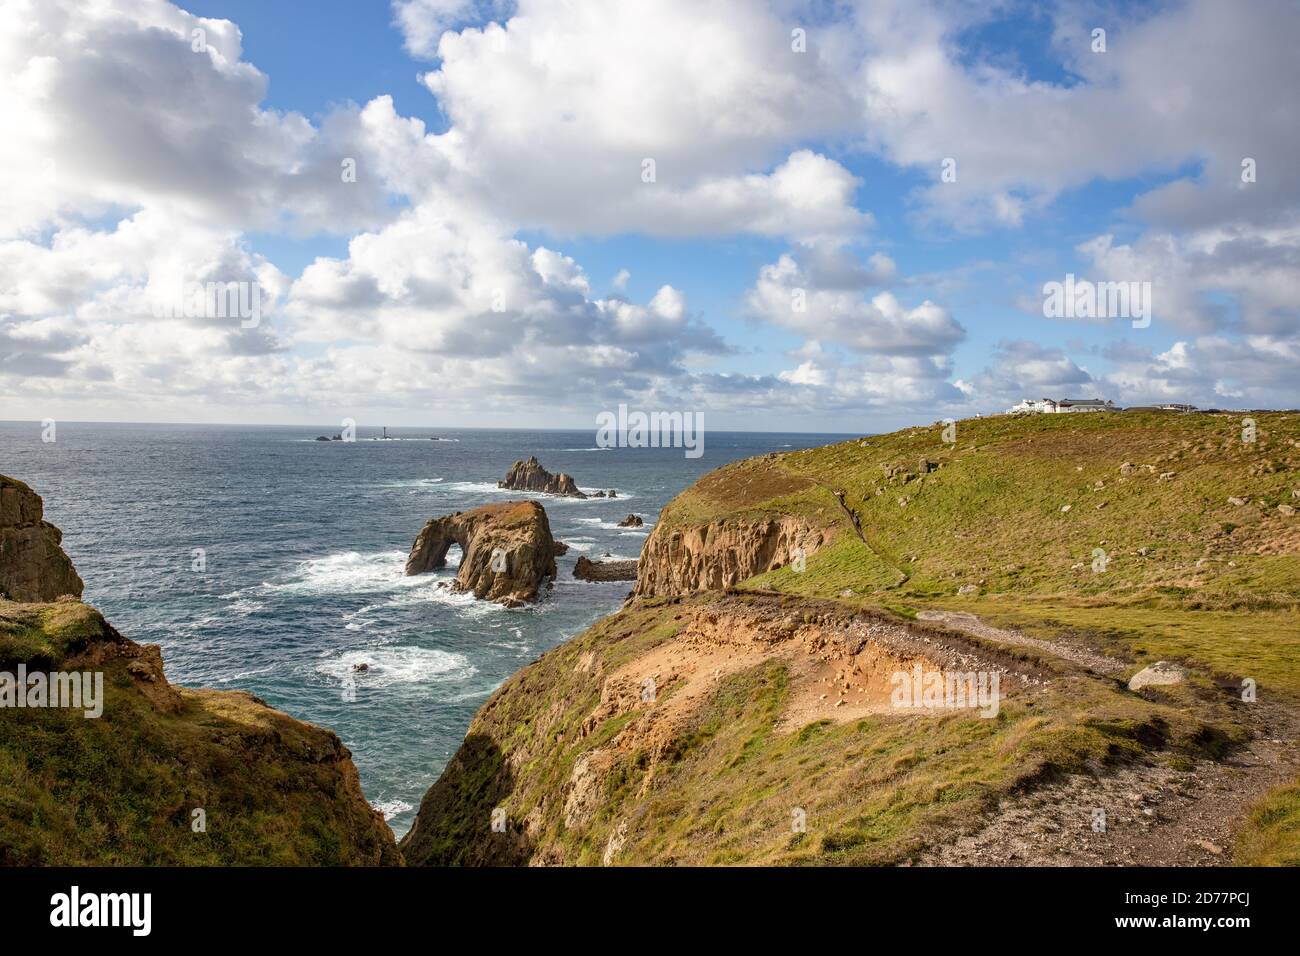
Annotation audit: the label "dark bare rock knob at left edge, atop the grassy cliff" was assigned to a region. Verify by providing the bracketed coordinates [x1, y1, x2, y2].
[0, 475, 82, 601]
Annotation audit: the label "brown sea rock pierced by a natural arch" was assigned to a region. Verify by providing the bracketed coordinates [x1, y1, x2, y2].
[406, 501, 556, 607]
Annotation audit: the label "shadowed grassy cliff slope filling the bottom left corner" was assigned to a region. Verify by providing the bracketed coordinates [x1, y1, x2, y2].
[0, 479, 402, 866]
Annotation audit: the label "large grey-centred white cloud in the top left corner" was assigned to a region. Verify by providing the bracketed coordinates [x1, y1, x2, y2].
[0, 0, 405, 237]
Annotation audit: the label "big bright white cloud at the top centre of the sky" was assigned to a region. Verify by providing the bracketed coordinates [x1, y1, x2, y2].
[402, 0, 870, 238]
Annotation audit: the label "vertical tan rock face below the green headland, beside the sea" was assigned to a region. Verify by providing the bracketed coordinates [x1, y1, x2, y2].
[636, 515, 833, 597]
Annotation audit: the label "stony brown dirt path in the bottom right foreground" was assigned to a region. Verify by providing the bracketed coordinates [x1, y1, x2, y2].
[914, 702, 1300, 866]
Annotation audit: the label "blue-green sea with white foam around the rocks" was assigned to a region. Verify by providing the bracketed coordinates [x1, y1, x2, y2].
[0, 421, 845, 838]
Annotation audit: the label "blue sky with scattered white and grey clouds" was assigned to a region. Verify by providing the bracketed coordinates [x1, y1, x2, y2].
[0, 0, 1300, 432]
